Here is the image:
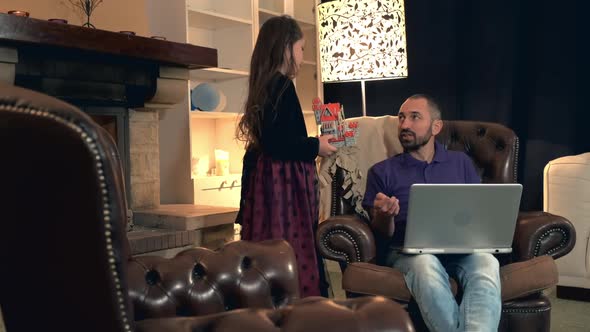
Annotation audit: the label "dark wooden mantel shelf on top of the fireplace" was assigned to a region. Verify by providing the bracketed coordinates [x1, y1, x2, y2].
[0, 13, 217, 69]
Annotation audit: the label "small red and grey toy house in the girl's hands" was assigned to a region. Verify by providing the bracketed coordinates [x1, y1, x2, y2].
[312, 97, 358, 148]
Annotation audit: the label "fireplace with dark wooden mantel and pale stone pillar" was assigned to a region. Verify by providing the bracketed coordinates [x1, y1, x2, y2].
[0, 13, 217, 213]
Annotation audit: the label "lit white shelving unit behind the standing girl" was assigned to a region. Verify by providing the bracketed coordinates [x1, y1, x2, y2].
[186, 0, 323, 206]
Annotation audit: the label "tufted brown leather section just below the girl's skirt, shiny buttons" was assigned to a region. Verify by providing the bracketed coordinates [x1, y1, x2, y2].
[128, 240, 299, 320]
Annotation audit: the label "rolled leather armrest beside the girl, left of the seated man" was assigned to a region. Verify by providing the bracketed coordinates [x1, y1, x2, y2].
[316, 215, 376, 264]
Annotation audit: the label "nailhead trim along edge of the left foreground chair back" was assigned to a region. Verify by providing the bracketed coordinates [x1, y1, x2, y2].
[0, 105, 131, 332]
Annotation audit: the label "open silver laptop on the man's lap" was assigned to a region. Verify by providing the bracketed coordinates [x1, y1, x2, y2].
[402, 183, 522, 254]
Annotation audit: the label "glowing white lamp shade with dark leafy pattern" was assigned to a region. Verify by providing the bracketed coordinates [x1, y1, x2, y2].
[318, 0, 408, 82]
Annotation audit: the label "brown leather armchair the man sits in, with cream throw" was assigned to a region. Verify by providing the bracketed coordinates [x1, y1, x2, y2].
[317, 116, 575, 331]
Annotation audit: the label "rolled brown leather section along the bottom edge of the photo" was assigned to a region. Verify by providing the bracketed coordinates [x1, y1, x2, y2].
[137, 297, 414, 332]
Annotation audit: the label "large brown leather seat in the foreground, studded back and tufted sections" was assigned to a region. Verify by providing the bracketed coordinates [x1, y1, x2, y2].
[0, 83, 413, 332]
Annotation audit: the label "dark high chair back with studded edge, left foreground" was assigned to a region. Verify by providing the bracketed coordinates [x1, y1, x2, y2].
[0, 83, 133, 331]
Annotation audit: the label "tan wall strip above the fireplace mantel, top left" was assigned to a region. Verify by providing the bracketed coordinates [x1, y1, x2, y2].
[0, 0, 148, 36]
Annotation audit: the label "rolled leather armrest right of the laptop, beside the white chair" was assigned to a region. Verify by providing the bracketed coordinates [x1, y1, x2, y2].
[512, 211, 576, 261]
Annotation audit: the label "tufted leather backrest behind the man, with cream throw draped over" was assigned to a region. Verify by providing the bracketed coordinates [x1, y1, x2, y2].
[320, 116, 518, 219]
